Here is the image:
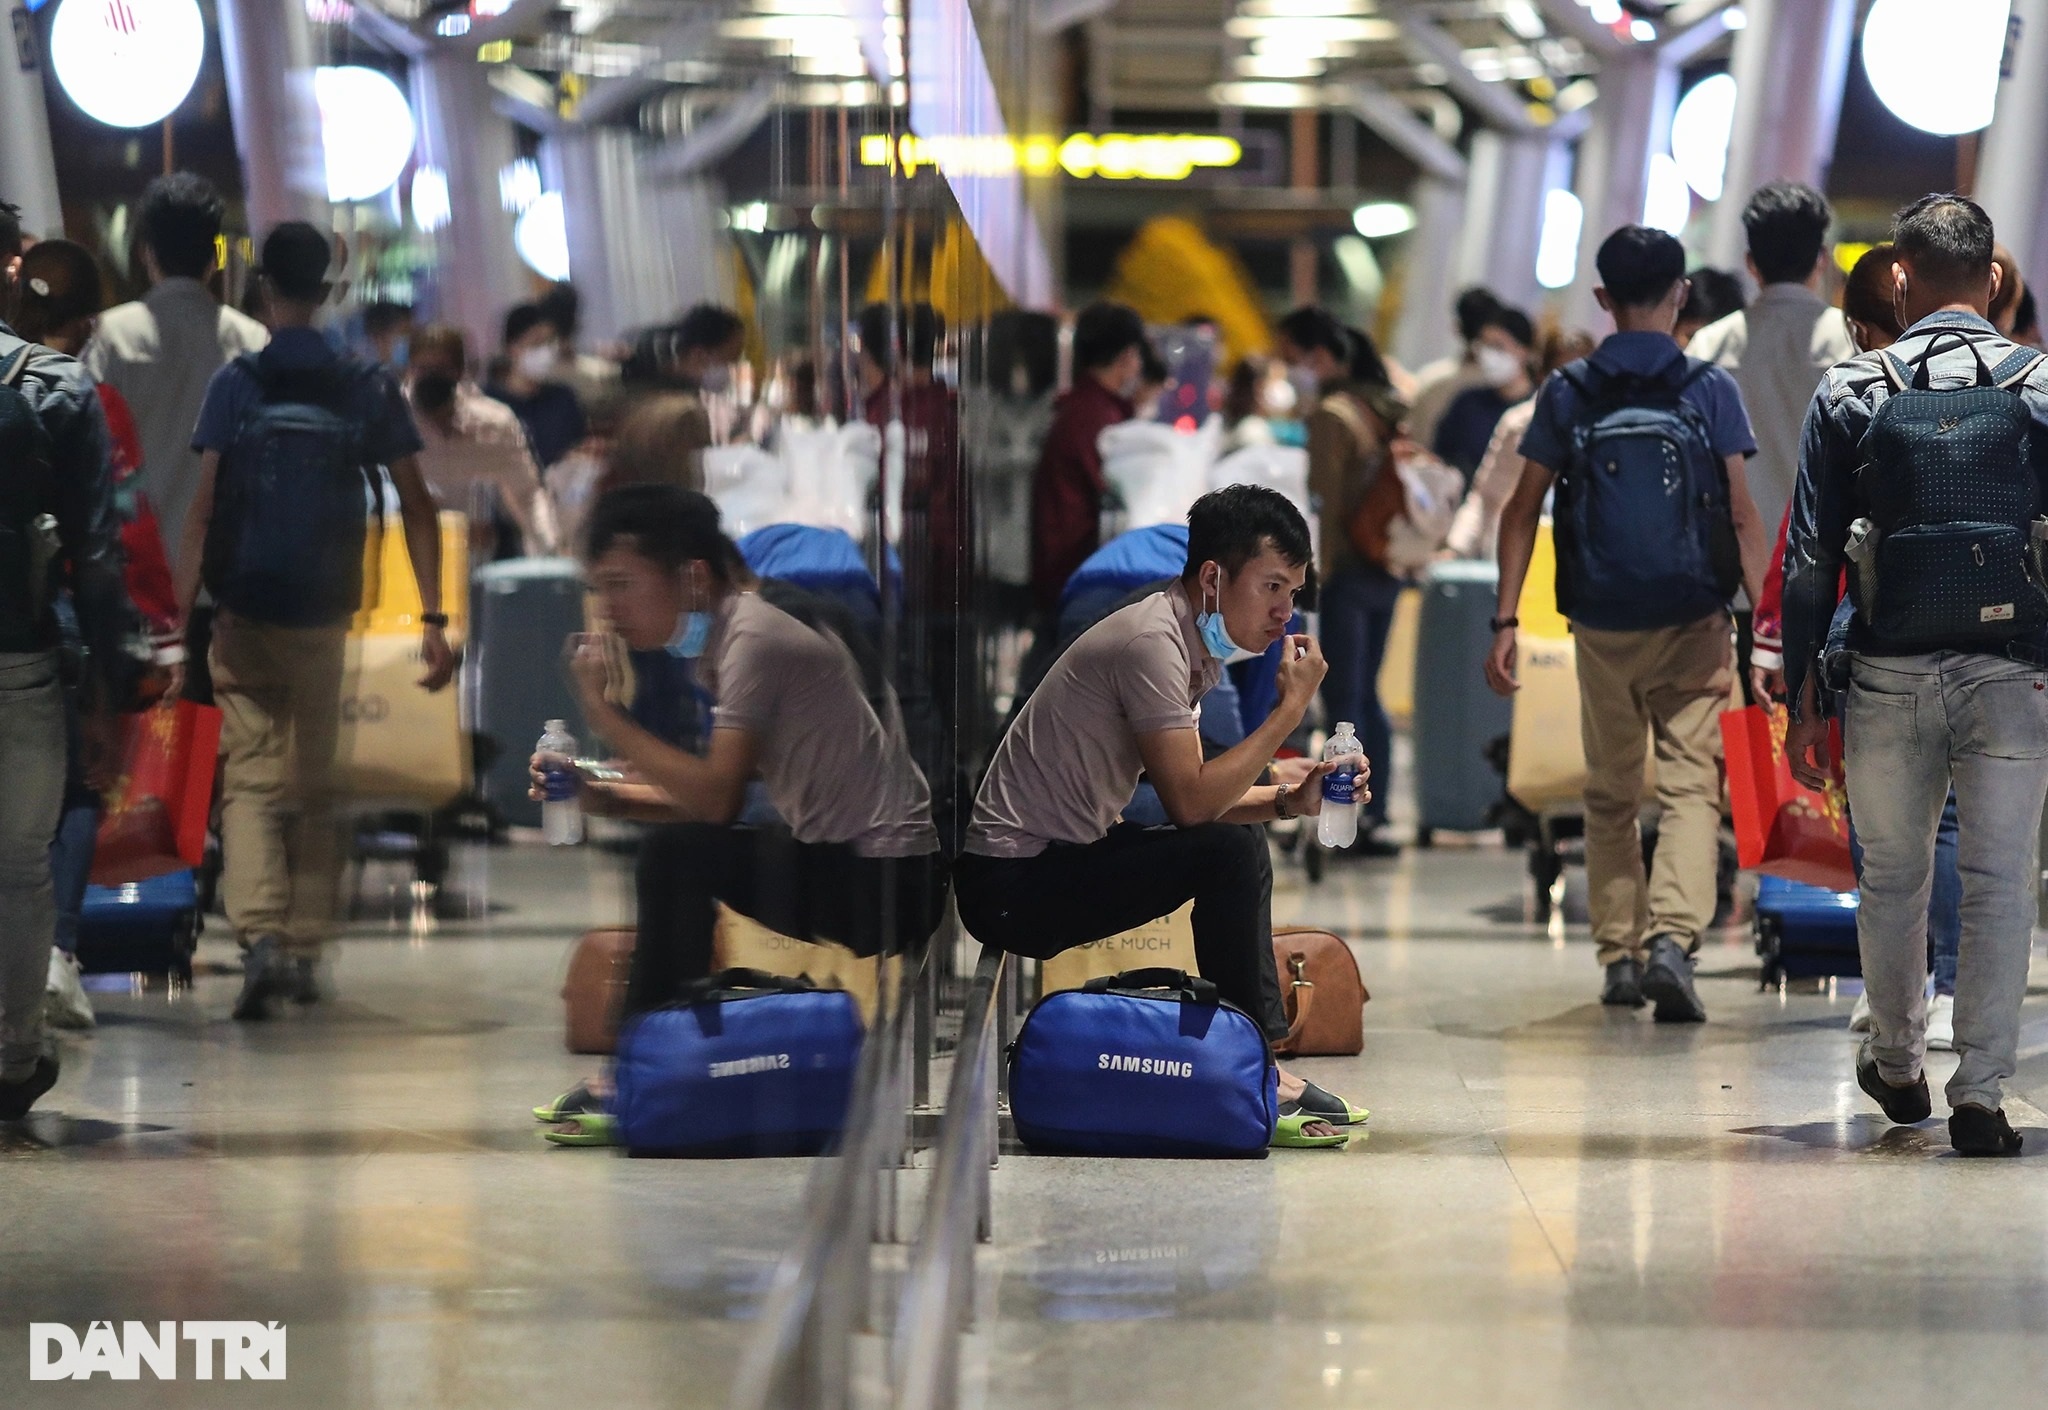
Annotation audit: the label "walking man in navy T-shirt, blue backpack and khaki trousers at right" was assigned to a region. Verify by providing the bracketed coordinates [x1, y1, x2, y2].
[1487, 225, 1769, 1023]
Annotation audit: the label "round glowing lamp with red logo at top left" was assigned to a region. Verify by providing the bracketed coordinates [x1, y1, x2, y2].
[49, 0, 207, 127]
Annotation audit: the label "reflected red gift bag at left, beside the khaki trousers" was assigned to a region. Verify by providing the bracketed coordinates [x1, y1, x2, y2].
[92, 701, 221, 885]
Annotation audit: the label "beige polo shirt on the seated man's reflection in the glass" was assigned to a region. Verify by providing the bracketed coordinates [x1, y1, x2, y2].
[696, 592, 938, 857]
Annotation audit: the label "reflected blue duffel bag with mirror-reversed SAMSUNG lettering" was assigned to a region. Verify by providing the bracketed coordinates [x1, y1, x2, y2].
[614, 969, 864, 1156]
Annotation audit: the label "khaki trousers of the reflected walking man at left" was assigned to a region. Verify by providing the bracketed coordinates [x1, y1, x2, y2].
[211, 613, 346, 957]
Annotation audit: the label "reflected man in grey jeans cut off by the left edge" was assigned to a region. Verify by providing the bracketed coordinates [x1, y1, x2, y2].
[0, 201, 127, 1121]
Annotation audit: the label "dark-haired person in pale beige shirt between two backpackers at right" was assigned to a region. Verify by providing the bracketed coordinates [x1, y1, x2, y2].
[1686, 180, 1855, 525]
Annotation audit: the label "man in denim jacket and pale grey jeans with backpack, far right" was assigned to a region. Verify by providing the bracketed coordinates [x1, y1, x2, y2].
[1786, 195, 2048, 1156]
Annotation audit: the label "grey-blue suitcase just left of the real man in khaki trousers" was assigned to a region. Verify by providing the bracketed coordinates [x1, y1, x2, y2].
[1415, 562, 1516, 846]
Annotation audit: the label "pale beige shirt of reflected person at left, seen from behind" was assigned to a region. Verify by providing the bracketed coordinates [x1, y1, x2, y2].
[80, 279, 270, 570]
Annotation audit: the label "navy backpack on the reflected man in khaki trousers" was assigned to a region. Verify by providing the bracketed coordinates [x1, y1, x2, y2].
[205, 353, 377, 627]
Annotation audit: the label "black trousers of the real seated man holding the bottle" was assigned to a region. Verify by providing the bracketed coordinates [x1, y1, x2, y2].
[952, 822, 1288, 1039]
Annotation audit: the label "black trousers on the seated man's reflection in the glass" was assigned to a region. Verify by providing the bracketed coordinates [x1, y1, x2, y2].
[625, 822, 946, 1014]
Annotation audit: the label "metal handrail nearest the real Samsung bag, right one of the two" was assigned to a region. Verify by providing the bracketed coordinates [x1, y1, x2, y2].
[891, 949, 1006, 1410]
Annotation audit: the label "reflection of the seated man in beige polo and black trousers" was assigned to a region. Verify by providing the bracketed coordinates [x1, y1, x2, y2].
[532, 484, 946, 1146]
